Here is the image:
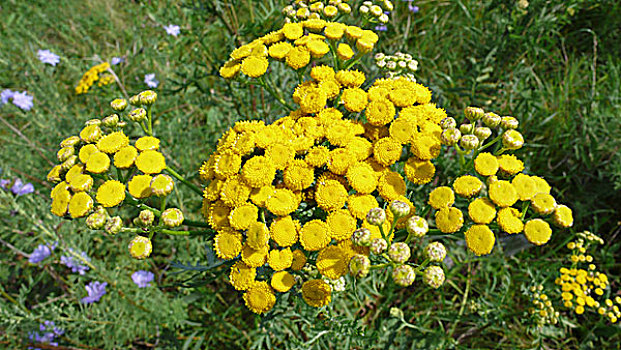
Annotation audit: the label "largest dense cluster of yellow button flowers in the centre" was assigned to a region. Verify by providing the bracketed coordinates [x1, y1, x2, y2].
[200, 65, 446, 313]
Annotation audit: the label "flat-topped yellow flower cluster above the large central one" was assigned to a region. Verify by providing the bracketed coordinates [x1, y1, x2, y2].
[220, 19, 379, 79]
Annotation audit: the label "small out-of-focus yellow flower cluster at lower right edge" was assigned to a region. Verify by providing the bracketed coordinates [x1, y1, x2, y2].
[555, 231, 621, 323]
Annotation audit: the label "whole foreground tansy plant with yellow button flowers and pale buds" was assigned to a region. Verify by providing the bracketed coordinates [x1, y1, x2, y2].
[48, 11, 573, 314]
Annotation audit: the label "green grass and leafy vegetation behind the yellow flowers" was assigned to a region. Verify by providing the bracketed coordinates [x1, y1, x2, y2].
[0, 0, 621, 349]
